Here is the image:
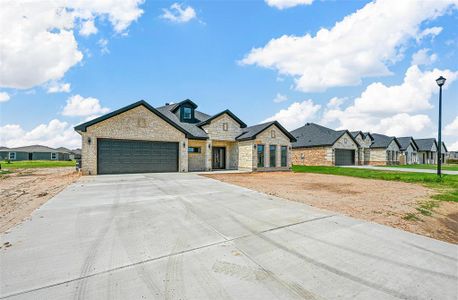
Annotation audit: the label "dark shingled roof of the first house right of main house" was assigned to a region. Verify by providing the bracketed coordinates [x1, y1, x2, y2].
[291, 123, 359, 148]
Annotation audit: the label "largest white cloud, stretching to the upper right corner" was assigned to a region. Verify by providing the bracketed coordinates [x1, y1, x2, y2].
[241, 0, 458, 92]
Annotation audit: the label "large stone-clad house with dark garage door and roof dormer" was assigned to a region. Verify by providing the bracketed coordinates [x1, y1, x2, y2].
[75, 99, 295, 174]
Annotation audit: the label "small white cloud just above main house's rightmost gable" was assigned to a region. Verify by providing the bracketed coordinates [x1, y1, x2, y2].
[264, 100, 321, 130]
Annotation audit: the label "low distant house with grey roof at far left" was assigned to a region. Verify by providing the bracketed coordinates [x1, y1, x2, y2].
[0, 145, 69, 160]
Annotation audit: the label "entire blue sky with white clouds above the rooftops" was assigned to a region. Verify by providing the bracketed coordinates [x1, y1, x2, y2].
[0, 0, 458, 150]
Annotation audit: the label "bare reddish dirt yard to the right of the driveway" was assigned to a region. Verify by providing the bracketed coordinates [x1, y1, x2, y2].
[205, 172, 458, 244]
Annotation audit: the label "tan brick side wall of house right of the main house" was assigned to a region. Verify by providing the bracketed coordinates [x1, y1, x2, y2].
[292, 147, 334, 166]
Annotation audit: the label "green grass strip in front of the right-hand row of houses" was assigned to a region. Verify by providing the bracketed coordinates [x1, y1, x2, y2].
[293, 166, 458, 202]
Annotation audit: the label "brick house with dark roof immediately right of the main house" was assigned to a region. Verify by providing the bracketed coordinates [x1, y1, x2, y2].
[291, 123, 359, 166]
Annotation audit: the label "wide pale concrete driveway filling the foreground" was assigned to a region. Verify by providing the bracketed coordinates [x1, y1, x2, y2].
[0, 174, 458, 299]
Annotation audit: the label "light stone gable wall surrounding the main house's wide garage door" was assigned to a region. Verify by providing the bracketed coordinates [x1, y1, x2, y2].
[80, 106, 188, 175]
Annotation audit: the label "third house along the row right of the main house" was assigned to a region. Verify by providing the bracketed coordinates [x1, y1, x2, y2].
[369, 133, 401, 166]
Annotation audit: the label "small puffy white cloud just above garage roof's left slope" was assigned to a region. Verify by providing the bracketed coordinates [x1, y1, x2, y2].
[62, 95, 110, 118]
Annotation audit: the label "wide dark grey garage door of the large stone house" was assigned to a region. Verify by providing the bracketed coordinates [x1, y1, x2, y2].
[97, 139, 178, 174]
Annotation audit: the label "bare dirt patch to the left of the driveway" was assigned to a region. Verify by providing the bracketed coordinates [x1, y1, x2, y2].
[0, 167, 80, 233]
